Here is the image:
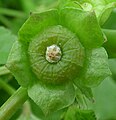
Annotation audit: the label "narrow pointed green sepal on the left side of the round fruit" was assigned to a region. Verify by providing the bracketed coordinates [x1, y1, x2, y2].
[6, 41, 34, 87]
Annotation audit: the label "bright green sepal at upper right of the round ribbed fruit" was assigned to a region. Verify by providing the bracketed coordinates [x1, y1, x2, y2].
[60, 7, 103, 48]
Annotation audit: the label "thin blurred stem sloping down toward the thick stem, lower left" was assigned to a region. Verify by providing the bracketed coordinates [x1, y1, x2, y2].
[0, 79, 15, 95]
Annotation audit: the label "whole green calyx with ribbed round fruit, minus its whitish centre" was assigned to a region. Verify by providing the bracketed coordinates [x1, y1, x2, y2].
[6, 0, 110, 115]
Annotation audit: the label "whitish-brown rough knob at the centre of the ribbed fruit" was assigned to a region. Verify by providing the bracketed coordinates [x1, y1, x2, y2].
[46, 45, 62, 63]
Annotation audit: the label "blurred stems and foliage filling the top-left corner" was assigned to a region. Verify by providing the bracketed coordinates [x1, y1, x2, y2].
[0, 0, 57, 34]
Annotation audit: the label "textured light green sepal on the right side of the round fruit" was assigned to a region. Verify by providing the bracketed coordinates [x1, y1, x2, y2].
[77, 47, 111, 87]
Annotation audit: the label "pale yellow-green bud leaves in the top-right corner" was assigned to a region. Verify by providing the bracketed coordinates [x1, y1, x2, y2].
[77, 0, 116, 25]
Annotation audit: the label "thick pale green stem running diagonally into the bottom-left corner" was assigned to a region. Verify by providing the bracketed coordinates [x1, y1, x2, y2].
[0, 87, 28, 120]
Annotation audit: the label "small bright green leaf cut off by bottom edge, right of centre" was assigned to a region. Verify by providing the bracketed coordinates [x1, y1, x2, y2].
[64, 106, 96, 120]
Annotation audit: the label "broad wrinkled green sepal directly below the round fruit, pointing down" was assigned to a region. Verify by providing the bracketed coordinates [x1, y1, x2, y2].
[28, 82, 75, 115]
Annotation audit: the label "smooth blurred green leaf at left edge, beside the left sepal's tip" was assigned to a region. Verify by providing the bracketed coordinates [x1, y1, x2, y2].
[0, 27, 17, 64]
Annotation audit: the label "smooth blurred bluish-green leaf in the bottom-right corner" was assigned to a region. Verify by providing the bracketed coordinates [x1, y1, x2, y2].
[88, 77, 116, 120]
